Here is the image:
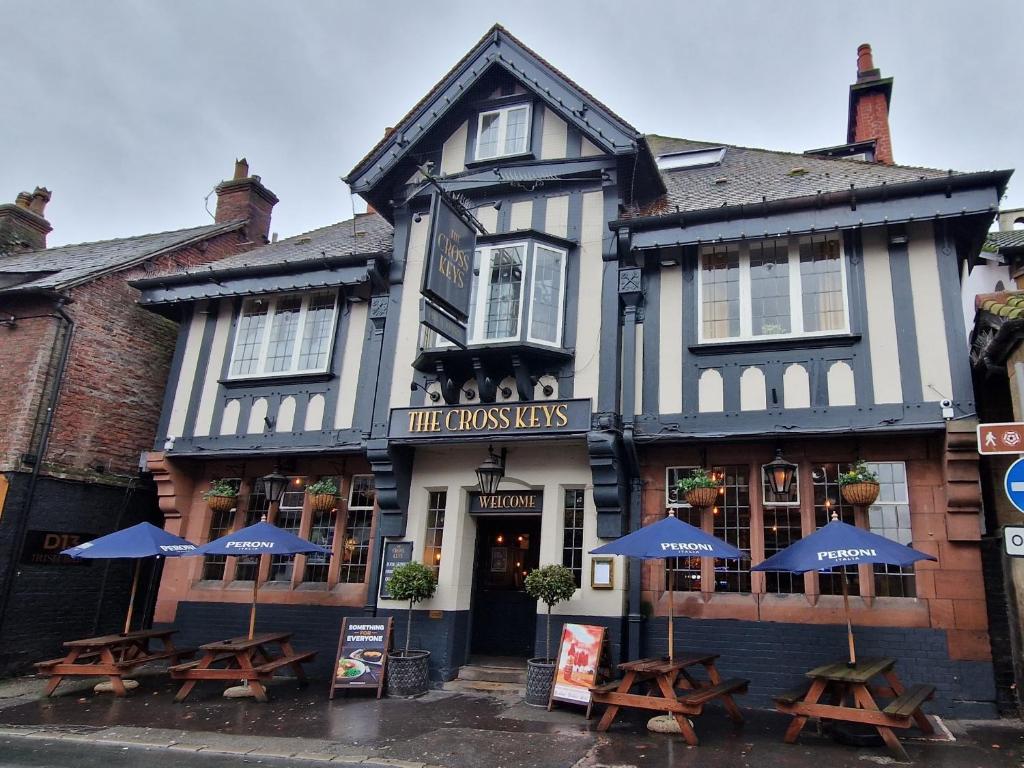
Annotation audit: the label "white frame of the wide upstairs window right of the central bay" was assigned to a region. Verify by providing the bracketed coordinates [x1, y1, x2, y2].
[696, 233, 850, 344]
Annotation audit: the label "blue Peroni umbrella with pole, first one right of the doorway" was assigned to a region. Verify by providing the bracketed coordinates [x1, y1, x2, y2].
[590, 514, 746, 660]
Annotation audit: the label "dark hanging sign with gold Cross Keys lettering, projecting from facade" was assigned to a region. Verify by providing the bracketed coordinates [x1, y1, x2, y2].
[420, 193, 476, 324]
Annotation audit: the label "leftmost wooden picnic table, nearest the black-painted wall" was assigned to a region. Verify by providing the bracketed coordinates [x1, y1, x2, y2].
[36, 630, 196, 696]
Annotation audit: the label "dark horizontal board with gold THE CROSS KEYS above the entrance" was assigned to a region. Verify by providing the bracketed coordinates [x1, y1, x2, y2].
[388, 400, 591, 439]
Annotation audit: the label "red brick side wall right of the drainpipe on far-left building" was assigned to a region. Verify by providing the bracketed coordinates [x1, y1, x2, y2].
[46, 231, 247, 477]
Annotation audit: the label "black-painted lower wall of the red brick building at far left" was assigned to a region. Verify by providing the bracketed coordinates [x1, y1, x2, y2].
[0, 472, 162, 674]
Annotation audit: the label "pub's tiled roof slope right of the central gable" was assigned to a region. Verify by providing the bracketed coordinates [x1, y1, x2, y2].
[632, 134, 963, 216]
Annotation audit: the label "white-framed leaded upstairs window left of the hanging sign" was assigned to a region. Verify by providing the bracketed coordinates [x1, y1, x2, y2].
[230, 291, 337, 379]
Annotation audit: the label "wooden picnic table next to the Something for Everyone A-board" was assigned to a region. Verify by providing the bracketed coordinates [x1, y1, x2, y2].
[171, 632, 316, 701]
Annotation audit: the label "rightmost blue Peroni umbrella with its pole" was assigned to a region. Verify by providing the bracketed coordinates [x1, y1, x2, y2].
[753, 512, 936, 665]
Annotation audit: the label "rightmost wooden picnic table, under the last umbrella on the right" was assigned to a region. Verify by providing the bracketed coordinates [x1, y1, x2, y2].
[775, 658, 935, 760]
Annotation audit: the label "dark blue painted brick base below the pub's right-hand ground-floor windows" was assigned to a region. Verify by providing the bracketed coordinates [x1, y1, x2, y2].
[643, 616, 996, 718]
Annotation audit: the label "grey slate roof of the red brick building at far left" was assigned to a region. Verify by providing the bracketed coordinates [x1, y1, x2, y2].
[0, 221, 245, 292]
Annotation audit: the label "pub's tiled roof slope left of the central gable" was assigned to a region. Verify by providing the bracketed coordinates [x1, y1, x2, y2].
[149, 213, 394, 282]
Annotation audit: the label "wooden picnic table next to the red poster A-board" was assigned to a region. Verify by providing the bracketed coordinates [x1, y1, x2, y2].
[590, 652, 750, 745]
